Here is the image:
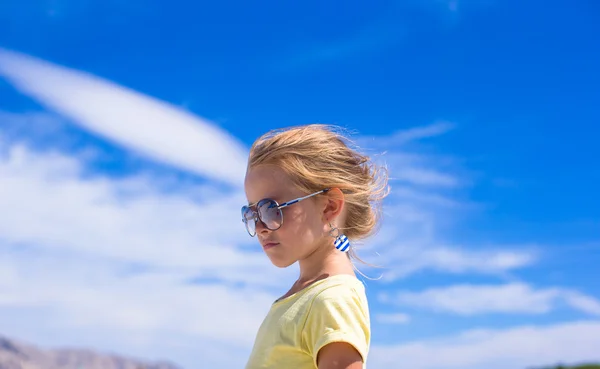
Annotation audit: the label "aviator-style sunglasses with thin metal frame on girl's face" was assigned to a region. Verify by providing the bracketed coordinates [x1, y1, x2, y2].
[242, 188, 329, 237]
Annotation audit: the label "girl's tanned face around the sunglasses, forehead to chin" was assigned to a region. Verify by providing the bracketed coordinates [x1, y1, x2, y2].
[244, 165, 331, 268]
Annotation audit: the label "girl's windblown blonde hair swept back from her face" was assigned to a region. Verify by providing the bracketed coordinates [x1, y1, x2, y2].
[248, 124, 389, 247]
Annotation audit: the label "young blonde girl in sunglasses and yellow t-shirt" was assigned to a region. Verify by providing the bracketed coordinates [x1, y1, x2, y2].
[242, 125, 387, 369]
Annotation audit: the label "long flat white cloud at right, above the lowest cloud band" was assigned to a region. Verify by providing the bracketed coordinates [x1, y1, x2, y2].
[385, 283, 600, 315]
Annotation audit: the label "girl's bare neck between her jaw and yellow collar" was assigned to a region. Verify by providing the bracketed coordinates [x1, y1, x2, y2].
[298, 237, 354, 282]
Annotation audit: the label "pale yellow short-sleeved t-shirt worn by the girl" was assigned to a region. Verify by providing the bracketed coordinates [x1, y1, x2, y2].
[246, 275, 371, 369]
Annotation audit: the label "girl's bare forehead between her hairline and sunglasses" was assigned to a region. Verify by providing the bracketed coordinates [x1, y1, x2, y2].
[244, 164, 297, 204]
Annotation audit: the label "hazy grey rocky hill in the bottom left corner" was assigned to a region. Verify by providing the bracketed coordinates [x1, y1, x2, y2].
[0, 336, 181, 369]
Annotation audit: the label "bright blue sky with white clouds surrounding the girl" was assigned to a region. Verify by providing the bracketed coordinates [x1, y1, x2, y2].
[0, 0, 600, 368]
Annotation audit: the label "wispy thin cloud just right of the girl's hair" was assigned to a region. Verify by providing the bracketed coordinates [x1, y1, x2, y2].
[356, 121, 540, 282]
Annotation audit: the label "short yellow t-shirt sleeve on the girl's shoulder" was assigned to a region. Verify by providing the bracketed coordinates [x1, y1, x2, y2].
[302, 285, 371, 367]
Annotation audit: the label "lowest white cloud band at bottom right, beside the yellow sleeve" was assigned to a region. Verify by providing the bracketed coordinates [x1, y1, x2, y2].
[369, 321, 600, 369]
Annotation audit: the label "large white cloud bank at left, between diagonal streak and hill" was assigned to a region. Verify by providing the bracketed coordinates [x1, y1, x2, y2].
[0, 136, 284, 368]
